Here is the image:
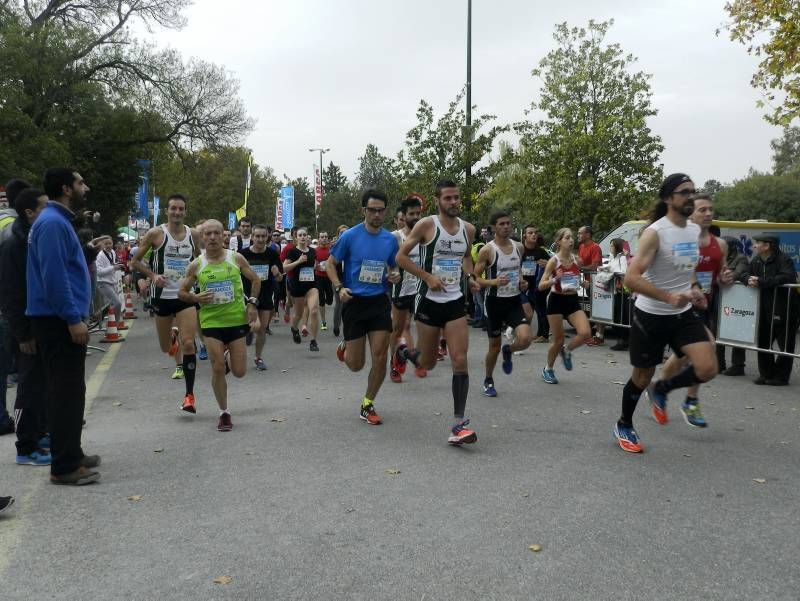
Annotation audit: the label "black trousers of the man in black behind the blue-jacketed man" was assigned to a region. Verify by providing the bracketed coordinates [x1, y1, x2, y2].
[13, 340, 46, 455]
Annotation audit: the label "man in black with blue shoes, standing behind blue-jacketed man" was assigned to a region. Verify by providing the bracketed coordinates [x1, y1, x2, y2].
[0, 188, 50, 465]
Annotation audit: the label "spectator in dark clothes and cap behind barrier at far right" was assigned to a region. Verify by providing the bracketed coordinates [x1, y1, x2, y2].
[739, 234, 800, 386]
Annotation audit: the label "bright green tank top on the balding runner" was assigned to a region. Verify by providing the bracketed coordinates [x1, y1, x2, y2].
[197, 250, 247, 329]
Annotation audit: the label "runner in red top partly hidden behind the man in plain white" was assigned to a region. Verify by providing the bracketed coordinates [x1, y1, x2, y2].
[647, 194, 733, 428]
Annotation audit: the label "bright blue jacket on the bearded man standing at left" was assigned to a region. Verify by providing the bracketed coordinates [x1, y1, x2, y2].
[25, 202, 92, 325]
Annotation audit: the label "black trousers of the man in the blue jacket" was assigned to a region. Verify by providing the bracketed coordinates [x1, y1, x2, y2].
[31, 317, 86, 476]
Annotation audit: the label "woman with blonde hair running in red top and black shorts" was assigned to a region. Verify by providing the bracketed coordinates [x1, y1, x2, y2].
[539, 227, 592, 384]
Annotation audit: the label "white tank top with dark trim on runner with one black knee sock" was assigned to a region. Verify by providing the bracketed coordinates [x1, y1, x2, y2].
[417, 215, 469, 303]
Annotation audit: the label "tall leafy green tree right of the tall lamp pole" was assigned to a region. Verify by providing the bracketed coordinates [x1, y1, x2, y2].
[516, 21, 663, 230]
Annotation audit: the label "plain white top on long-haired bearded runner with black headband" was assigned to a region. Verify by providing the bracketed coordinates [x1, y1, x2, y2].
[636, 216, 700, 315]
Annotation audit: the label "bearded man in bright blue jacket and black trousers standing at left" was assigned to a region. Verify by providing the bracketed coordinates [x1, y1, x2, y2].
[26, 168, 100, 485]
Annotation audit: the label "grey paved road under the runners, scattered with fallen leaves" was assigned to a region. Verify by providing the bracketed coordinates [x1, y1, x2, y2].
[0, 318, 800, 601]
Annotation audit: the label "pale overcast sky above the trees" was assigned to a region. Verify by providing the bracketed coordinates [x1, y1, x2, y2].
[148, 0, 780, 184]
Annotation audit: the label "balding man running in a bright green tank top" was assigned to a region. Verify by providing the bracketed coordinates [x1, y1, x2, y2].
[178, 219, 261, 432]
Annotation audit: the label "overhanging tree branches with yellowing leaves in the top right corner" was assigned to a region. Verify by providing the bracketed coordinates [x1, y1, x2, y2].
[717, 0, 800, 126]
